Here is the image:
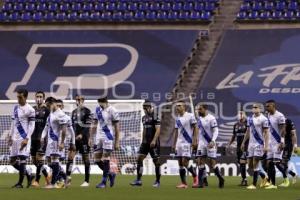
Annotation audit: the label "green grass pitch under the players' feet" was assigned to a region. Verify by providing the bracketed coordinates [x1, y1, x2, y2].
[0, 174, 300, 200]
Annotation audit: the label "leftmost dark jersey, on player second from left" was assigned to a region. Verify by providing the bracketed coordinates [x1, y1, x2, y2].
[31, 106, 50, 140]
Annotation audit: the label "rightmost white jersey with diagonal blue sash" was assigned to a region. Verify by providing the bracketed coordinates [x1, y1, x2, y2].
[268, 110, 285, 145]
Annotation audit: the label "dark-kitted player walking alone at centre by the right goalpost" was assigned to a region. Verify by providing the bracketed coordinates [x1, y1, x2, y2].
[131, 100, 161, 187]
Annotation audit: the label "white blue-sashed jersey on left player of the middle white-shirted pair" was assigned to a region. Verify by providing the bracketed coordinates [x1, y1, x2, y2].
[175, 112, 197, 146]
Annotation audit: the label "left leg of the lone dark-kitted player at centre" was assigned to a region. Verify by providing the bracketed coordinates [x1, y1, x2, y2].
[130, 143, 150, 186]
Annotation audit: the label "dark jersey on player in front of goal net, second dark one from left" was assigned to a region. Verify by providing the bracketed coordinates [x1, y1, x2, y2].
[72, 106, 92, 140]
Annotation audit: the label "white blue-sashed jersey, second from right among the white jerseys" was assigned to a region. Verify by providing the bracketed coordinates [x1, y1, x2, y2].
[247, 113, 269, 145]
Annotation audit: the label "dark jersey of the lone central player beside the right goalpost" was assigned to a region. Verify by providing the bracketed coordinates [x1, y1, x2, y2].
[142, 113, 160, 144]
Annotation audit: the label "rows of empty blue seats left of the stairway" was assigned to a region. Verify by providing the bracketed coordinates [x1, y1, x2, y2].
[0, 0, 219, 23]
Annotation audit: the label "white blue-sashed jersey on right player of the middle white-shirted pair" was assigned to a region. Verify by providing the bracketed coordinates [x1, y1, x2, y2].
[197, 113, 218, 145]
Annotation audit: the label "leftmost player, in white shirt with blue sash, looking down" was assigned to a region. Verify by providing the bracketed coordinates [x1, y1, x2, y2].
[8, 89, 35, 188]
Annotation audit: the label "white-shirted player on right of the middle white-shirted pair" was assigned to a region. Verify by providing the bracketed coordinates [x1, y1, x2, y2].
[197, 103, 225, 188]
